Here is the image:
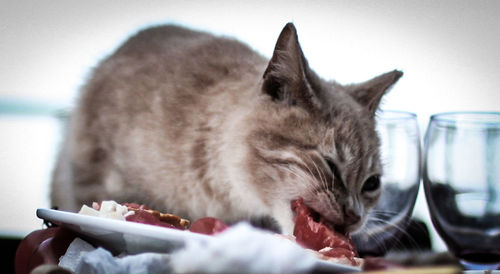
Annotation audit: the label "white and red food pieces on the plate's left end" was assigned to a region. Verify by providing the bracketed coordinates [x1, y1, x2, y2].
[78, 201, 190, 230]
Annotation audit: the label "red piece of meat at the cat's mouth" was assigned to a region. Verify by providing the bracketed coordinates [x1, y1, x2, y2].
[291, 198, 361, 266]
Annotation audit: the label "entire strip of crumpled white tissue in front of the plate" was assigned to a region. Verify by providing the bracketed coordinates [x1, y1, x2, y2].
[59, 223, 317, 274]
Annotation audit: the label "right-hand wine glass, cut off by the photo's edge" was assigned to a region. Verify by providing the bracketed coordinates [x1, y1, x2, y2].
[423, 112, 500, 270]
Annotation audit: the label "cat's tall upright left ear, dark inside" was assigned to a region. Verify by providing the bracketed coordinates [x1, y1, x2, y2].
[262, 23, 318, 110]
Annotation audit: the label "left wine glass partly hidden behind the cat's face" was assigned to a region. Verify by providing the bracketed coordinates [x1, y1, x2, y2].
[353, 111, 421, 256]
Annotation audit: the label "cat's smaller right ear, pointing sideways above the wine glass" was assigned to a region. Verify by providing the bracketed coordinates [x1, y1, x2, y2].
[346, 70, 403, 115]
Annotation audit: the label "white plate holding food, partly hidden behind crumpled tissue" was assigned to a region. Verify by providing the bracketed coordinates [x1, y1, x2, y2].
[36, 208, 360, 272]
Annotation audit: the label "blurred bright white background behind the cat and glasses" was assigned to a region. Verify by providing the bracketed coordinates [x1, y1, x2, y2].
[0, 0, 500, 253]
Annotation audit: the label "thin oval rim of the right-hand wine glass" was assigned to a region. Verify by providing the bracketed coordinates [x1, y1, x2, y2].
[430, 111, 500, 127]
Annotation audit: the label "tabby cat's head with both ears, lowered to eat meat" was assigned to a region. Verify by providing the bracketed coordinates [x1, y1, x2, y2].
[248, 24, 402, 232]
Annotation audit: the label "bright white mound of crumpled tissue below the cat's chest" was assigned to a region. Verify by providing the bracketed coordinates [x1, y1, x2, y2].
[171, 223, 317, 273]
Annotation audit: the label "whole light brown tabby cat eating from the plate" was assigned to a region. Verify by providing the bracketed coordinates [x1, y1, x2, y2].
[51, 23, 402, 234]
